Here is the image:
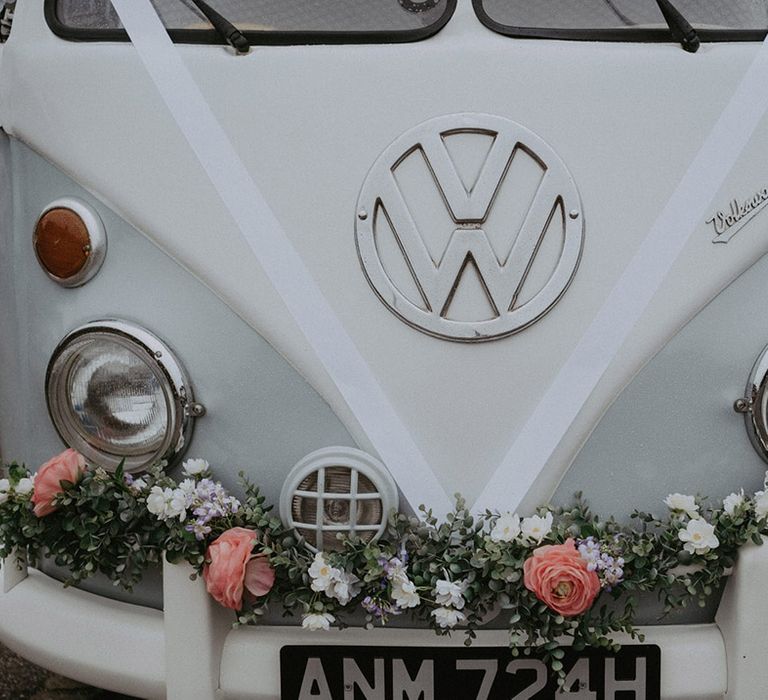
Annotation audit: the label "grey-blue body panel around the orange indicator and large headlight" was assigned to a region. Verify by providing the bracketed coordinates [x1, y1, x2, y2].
[0, 139, 355, 606]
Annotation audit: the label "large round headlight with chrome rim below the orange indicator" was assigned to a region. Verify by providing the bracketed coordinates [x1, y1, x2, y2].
[46, 321, 203, 472]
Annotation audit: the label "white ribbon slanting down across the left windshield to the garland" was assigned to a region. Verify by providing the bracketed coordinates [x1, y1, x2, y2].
[112, 0, 451, 516]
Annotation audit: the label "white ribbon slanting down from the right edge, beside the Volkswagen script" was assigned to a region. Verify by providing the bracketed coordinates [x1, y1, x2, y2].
[475, 39, 768, 510]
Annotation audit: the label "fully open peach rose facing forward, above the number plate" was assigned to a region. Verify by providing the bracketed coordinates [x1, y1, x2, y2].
[523, 539, 600, 617]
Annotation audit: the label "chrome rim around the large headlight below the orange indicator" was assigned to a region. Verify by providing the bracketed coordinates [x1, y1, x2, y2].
[45, 319, 204, 473]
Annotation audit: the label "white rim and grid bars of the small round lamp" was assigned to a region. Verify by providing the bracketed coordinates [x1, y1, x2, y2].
[280, 446, 399, 552]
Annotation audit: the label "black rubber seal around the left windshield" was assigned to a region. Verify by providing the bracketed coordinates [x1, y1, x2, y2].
[44, 0, 457, 46]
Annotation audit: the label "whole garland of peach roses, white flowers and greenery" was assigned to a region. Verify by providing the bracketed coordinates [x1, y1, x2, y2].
[0, 450, 768, 679]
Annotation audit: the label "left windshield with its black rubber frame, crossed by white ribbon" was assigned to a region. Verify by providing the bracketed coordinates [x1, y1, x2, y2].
[46, 0, 456, 43]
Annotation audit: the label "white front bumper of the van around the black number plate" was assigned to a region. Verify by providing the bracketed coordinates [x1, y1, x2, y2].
[0, 547, 768, 700]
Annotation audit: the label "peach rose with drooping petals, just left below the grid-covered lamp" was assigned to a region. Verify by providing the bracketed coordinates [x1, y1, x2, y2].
[203, 527, 275, 610]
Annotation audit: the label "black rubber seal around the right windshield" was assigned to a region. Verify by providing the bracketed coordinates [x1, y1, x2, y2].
[472, 0, 768, 43]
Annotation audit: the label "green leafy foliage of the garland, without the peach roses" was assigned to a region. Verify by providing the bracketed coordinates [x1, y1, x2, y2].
[0, 454, 768, 678]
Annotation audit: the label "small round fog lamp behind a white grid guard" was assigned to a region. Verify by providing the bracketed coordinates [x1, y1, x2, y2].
[280, 447, 398, 550]
